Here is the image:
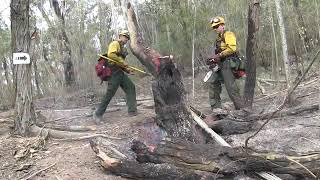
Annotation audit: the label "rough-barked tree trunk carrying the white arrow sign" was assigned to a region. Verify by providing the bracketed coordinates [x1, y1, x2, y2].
[10, 0, 35, 135]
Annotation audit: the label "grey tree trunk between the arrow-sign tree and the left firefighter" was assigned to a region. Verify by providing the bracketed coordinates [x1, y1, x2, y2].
[52, 0, 75, 86]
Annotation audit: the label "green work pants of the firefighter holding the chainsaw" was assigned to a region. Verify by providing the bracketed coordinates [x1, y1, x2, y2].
[209, 58, 240, 109]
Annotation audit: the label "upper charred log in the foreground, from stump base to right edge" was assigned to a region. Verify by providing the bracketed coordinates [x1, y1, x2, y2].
[132, 139, 320, 178]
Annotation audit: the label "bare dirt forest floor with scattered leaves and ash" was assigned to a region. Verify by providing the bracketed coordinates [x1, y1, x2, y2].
[0, 71, 320, 180]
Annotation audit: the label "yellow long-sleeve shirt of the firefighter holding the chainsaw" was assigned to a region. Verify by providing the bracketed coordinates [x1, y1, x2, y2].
[216, 31, 237, 57]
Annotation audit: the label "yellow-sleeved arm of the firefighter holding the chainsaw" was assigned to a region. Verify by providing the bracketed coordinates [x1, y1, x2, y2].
[219, 31, 237, 57]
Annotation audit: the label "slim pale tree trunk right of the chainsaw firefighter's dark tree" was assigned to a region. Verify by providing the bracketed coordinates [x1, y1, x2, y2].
[275, 0, 291, 88]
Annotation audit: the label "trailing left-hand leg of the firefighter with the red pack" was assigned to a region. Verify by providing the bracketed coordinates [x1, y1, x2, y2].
[95, 74, 122, 117]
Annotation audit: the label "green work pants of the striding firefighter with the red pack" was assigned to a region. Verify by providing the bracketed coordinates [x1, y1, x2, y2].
[96, 70, 137, 116]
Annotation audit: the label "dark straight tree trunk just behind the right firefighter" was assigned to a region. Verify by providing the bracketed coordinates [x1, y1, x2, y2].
[244, 0, 260, 107]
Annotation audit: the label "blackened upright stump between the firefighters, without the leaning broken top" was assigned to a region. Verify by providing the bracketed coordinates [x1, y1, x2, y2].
[152, 58, 204, 143]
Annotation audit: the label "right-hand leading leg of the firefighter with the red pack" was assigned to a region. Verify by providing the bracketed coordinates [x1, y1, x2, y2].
[120, 74, 137, 113]
